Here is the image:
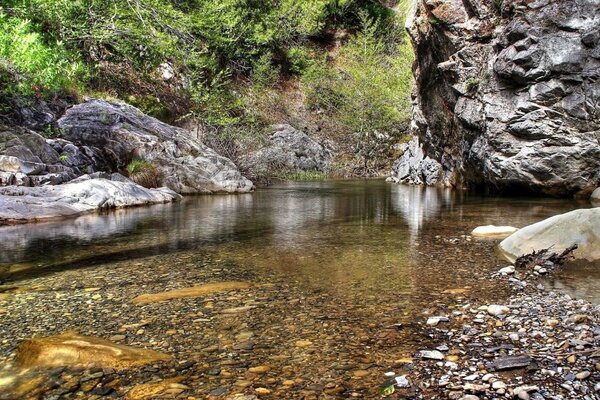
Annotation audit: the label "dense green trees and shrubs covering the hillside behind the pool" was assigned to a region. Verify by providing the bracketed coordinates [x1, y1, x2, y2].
[0, 0, 412, 175]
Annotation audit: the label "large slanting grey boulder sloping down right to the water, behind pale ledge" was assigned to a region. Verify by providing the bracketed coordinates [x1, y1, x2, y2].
[58, 100, 254, 194]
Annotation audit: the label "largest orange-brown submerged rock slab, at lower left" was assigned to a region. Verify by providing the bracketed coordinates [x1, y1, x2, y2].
[15, 333, 172, 369]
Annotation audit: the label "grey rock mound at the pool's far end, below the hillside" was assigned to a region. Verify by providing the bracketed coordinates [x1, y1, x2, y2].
[242, 125, 331, 176]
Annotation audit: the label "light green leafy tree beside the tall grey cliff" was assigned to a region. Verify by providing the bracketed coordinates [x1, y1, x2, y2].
[303, 12, 413, 170]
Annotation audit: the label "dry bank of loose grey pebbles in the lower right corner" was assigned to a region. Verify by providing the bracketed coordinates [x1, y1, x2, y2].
[390, 258, 600, 400]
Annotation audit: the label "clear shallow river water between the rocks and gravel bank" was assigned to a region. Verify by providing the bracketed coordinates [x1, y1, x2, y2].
[0, 180, 600, 398]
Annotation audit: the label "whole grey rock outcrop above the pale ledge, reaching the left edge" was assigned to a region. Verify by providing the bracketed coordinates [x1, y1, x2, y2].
[0, 100, 253, 194]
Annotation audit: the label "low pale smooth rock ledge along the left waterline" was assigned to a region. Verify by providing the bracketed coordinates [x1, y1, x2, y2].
[0, 174, 181, 225]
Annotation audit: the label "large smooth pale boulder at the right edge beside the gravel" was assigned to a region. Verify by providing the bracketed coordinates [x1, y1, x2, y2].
[499, 207, 600, 262]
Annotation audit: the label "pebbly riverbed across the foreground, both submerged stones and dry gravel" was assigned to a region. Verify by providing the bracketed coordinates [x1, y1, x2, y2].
[0, 241, 600, 400]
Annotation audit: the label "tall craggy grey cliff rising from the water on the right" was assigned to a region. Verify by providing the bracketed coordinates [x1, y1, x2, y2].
[394, 0, 600, 196]
